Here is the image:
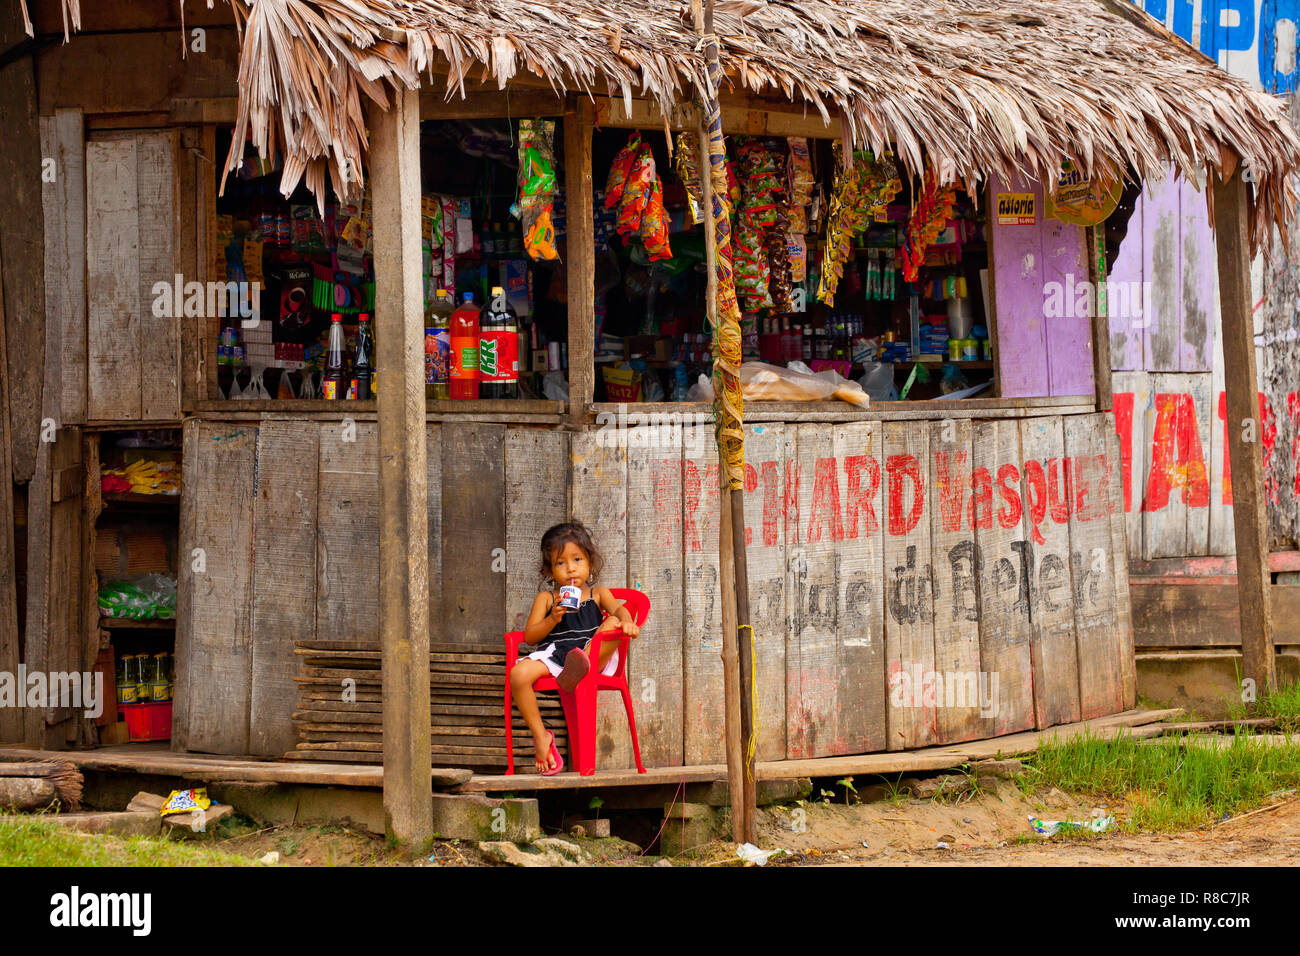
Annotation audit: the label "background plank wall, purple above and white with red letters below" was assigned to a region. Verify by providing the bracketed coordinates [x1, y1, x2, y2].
[1109, 167, 1300, 561]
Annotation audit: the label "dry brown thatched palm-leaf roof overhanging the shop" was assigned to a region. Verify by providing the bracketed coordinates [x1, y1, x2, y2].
[20, 0, 1300, 244]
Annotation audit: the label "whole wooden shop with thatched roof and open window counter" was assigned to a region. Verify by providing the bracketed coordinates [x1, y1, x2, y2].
[0, 0, 1300, 840]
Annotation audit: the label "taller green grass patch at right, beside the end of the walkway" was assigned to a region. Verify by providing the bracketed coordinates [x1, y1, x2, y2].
[1018, 731, 1300, 832]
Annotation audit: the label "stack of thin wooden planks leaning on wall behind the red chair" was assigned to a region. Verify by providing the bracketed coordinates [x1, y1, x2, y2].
[285, 641, 567, 773]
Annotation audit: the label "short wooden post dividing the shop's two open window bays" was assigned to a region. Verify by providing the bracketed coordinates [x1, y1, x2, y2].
[564, 96, 595, 421]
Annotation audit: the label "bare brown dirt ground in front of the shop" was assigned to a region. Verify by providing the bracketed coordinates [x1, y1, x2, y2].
[195, 783, 1300, 866]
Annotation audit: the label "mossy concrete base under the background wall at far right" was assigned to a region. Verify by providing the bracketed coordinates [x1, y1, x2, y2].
[1136, 648, 1300, 719]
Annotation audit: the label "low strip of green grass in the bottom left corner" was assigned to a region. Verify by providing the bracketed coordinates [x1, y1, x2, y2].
[0, 817, 254, 866]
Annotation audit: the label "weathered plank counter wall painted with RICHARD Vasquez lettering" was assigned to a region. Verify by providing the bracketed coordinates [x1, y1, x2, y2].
[177, 415, 1131, 769]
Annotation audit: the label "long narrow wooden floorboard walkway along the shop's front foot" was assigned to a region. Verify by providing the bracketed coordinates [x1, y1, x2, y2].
[0, 708, 1182, 793]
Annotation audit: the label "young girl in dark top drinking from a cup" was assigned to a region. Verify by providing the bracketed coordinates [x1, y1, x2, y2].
[510, 522, 638, 777]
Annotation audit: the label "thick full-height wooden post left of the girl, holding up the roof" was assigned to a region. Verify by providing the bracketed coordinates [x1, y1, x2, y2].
[369, 90, 433, 852]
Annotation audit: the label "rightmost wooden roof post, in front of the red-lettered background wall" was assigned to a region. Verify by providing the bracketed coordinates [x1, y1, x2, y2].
[1214, 172, 1277, 693]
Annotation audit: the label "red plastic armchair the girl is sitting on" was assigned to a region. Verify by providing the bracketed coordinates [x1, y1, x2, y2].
[506, 588, 650, 777]
